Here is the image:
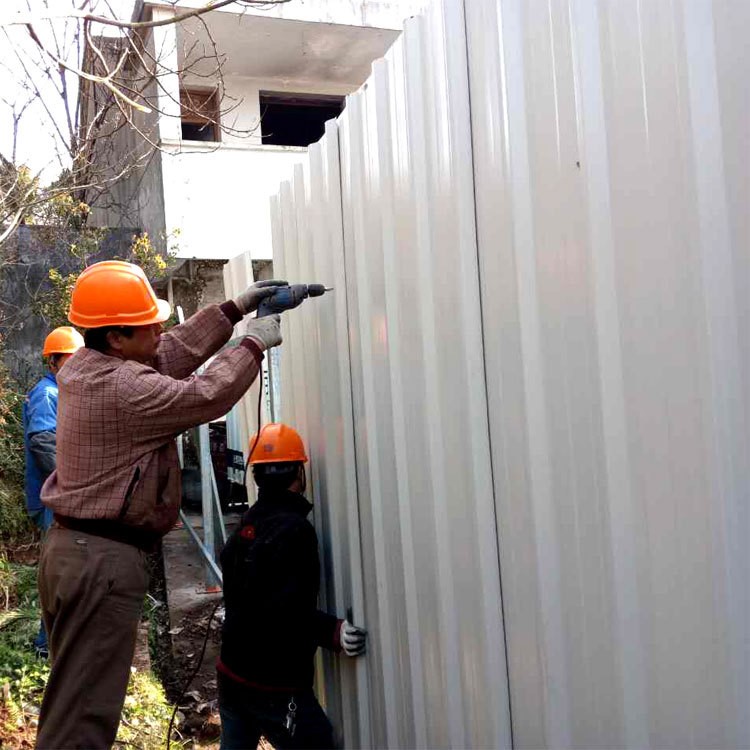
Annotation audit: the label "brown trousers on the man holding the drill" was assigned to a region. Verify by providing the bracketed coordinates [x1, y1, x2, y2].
[36, 526, 148, 750]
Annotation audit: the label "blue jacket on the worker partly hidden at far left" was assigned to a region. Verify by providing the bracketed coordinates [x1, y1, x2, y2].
[22, 372, 57, 513]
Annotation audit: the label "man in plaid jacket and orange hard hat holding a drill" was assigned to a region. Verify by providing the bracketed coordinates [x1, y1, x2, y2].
[37, 261, 288, 750]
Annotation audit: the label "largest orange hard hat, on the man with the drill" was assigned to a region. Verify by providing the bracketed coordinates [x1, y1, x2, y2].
[68, 260, 172, 328]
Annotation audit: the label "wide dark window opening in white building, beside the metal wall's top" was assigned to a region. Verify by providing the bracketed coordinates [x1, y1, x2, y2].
[260, 91, 344, 146]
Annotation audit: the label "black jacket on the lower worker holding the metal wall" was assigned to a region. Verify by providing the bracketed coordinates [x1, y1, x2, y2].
[219, 492, 339, 689]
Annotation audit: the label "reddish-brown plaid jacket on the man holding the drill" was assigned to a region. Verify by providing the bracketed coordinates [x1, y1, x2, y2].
[42, 303, 263, 534]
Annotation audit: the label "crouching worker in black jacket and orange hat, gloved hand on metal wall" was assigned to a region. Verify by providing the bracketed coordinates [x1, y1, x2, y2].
[217, 424, 366, 750]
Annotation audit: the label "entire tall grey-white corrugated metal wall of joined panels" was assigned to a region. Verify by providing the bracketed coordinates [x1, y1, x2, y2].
[229, 0, 750, 748]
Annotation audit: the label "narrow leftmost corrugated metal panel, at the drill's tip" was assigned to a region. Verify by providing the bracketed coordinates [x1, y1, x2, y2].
[272, 140, 369, 745]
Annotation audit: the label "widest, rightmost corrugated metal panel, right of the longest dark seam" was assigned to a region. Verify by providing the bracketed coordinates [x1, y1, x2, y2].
[466, 0, 750, 747]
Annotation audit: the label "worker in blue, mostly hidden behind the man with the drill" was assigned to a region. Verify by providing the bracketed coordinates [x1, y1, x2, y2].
[22, 326, 83, 657]
